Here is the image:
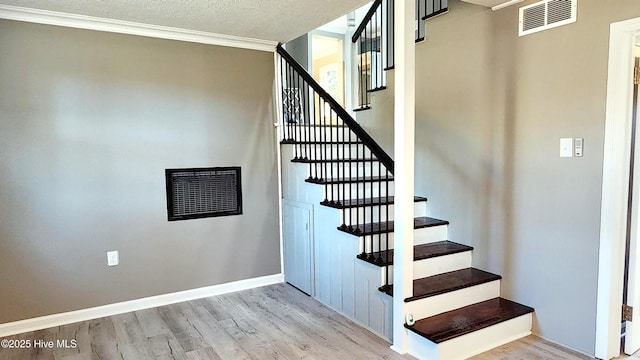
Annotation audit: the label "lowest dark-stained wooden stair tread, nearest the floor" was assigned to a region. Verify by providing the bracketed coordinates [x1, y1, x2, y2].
[405, 298, 534, 344]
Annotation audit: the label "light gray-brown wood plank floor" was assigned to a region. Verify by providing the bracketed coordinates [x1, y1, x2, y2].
[0, 284, 600, 360]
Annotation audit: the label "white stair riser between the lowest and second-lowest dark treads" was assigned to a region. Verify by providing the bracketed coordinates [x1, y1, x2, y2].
[407, 280, 500, 320]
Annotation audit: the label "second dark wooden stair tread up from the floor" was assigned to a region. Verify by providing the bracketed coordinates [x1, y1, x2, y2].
[383, 268, 502, 302]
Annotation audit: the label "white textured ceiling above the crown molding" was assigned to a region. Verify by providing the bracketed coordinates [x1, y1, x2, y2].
[0, 0, 369, 42]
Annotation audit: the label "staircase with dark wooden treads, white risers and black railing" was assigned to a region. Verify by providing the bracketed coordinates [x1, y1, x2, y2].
[277, 1, 534, 359]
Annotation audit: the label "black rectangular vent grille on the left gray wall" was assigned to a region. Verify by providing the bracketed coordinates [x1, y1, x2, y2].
[165, 166, 242, 221]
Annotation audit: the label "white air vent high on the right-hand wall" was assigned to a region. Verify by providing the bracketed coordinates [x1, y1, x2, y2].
[519, 0, 578, 36]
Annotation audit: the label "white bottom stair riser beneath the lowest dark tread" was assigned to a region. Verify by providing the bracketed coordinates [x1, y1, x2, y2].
[408, 313, 532, 360]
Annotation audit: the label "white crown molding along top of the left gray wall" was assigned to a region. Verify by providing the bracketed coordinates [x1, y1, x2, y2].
[0, 5, 278, 52]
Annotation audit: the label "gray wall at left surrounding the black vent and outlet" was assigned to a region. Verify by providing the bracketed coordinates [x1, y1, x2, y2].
[0, 20, 280, 323]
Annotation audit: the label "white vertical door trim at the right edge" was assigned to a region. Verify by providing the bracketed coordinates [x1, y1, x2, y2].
[595, 18, 640, 359]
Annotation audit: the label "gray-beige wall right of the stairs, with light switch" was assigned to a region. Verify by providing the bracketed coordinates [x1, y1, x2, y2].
[358, 0, 640, 354]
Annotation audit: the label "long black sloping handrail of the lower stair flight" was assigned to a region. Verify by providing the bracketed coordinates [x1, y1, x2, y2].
[276, 44, 394, 174]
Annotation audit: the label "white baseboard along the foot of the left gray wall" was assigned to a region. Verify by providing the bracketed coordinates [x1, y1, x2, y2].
[0, 274, 284, 337]
